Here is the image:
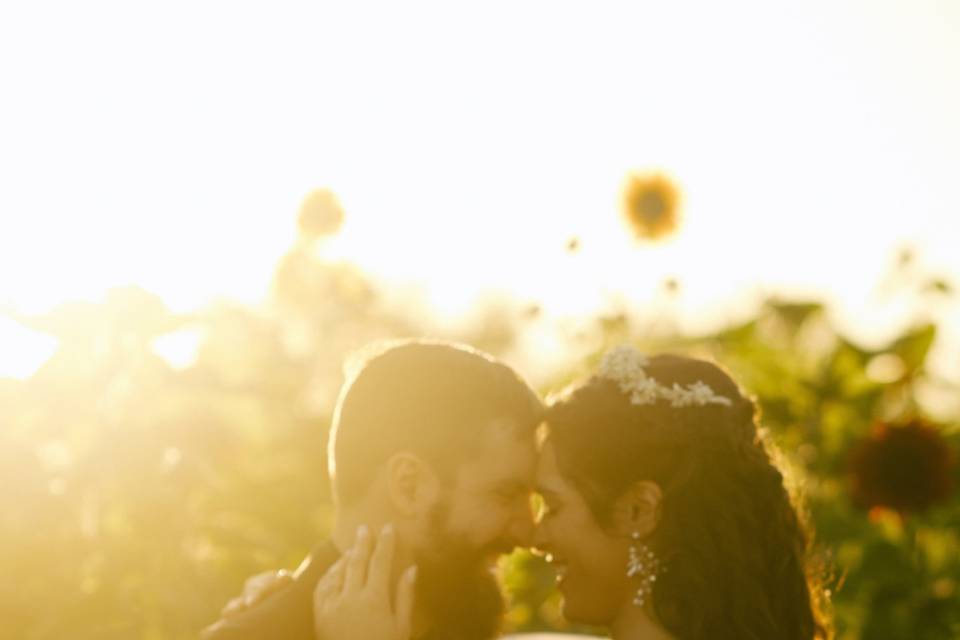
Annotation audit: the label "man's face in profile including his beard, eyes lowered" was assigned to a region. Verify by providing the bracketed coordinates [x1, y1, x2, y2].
[417, 424, 537, 639]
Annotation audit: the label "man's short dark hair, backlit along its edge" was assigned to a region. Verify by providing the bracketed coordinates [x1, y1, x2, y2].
[329, 340, 542, 505]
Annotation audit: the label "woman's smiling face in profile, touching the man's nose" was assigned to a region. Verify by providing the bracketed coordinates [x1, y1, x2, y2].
[534, 440, 633, 625]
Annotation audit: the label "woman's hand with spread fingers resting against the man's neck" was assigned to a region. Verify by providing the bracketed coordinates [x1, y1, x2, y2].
[313, 525, 416, 640]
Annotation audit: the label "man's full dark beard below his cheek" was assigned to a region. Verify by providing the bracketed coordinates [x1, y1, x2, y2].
[416, 503, 507, 640]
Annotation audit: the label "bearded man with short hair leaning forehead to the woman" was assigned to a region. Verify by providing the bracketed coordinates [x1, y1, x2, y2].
[203, 340, 542, 640]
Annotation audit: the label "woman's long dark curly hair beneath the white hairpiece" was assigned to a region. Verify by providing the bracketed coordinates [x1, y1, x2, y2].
[546, 355, 832, 640]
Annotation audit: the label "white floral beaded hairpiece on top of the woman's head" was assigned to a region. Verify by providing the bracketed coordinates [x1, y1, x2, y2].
[597, 345, 733, 408]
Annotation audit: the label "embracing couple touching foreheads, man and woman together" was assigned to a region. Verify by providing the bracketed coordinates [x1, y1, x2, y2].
[204, 341, 829, 640]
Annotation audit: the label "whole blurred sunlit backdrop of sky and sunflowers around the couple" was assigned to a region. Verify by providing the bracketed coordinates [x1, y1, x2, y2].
[0, 0, 960, 640]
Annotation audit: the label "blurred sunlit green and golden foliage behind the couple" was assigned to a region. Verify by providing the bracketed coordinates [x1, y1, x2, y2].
[0, 261, 960, 640]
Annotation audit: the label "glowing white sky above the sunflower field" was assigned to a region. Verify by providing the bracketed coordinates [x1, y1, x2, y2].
[0, 0, 960, 374]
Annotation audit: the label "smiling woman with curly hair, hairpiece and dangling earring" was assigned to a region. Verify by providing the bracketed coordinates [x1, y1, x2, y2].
[315, 347, 830, 640]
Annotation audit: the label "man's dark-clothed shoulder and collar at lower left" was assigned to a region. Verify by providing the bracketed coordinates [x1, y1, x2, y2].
[201, 543, 337, 640]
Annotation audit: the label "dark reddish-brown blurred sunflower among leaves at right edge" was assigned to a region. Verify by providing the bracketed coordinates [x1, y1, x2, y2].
[850, 420, 954, 512]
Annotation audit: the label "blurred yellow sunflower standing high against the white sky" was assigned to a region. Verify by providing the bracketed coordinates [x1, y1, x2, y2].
[623, 173, 680, 240]
